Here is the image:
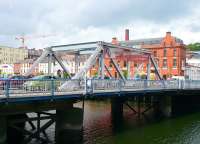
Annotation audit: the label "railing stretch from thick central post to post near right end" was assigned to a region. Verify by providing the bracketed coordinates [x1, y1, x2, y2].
[87, 79, 181, 93]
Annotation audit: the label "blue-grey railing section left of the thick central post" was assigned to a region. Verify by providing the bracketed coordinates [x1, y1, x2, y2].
[0, 79, 85, 98]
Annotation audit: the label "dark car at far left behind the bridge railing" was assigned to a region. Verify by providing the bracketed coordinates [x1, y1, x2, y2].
[0, 75, 26, 89]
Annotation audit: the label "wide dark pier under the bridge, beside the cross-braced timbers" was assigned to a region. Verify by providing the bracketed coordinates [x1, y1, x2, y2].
[56, 106, 83, 144]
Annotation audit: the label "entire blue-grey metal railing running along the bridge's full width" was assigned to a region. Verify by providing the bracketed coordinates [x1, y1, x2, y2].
[0, 79, 200, 98]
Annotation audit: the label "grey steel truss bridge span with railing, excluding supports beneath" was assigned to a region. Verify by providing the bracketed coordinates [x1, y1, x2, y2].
[0, 41, 200, 102]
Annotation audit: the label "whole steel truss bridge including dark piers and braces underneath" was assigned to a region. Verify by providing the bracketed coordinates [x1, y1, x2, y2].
[0, 41, 200, 144]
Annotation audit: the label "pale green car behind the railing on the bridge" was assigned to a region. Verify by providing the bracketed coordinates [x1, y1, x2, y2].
[23, 75, 60, 91]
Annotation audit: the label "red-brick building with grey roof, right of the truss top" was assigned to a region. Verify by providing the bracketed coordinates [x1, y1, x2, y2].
[120, 32, 186, 77]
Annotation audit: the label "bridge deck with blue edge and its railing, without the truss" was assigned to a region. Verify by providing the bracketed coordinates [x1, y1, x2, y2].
[0, 80, 200, 103]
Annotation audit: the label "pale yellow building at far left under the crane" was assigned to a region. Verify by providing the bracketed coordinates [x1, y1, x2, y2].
[0, 46, 28, 64]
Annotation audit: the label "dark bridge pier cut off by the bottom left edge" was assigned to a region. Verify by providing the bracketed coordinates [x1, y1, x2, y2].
[0, 116, 7, 144]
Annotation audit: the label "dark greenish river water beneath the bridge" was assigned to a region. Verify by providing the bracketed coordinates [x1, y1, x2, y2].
[31, 101, 200, 144]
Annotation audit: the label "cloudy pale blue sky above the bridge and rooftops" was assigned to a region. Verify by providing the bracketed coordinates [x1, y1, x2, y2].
[0, 0, 200, 48]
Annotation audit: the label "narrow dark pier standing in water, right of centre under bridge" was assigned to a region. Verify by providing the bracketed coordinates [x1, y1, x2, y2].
[111, 97, 123, 124]
